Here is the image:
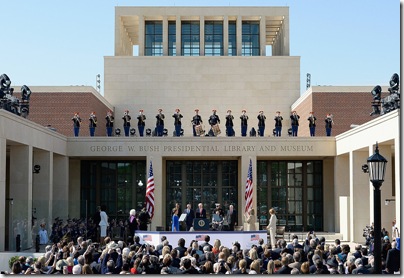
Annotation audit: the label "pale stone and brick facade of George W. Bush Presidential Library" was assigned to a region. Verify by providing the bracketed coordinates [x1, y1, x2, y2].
[0, 7, 401, 250]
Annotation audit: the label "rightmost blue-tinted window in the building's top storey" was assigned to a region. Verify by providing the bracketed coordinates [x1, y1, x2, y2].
[241, 21, 260, 56]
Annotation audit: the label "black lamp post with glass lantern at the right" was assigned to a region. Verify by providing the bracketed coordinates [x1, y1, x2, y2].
[367, 142, 387, 274]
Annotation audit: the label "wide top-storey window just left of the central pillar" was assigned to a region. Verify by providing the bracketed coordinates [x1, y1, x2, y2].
[181, 21, 200, 56]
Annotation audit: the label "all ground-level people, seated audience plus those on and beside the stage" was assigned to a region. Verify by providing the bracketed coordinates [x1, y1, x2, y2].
[5, 204, 401, 275]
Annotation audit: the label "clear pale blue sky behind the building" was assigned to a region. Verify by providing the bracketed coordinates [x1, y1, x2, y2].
[0, 0, 401, 94]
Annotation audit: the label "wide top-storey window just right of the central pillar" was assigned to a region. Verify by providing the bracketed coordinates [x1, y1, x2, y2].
[205, 21, 223, 56]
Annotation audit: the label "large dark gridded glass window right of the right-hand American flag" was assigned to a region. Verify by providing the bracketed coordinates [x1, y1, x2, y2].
[257, 161, 323, 231]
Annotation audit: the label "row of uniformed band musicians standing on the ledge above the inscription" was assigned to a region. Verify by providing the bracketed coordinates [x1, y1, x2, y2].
[72, 108, 334, 137]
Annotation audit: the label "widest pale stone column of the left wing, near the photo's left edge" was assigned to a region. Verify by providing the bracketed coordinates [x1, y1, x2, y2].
[10, 145, 33, 250]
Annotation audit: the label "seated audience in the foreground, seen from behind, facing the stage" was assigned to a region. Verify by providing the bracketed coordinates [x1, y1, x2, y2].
[4, 229, 401, 275]
